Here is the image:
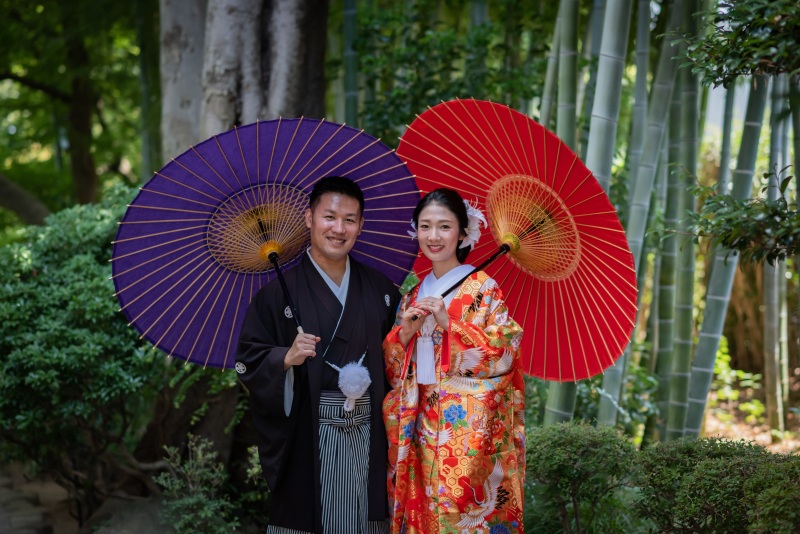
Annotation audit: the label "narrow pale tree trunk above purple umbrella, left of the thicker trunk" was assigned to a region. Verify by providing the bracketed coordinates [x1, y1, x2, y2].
[159, 0, 206, 158]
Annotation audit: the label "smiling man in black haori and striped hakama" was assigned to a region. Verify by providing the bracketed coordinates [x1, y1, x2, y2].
[236, 177, 400, 534]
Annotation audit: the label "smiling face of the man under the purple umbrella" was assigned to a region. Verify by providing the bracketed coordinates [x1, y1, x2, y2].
[306, 193, 364, 261]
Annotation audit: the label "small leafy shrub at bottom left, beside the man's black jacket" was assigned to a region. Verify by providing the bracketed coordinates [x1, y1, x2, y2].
[155, 435, 239, 534]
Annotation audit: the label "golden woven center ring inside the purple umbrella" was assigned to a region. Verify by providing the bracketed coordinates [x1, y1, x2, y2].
[206, 185, 308, 273]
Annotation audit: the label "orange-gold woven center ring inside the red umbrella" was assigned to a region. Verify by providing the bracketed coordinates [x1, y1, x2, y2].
[486, 174, 581, 281]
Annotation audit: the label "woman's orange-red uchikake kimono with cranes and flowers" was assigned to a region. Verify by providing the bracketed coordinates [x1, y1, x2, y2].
[383, 271, 525, 534]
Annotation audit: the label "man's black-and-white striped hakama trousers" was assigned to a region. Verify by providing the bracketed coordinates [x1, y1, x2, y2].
[267, 391, 388, 534]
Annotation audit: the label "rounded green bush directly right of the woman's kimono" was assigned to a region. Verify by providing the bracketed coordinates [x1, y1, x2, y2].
[525, 422, 635, 533]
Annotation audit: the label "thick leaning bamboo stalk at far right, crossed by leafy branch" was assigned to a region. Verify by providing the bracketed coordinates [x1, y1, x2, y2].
[686, 76, 768, 437]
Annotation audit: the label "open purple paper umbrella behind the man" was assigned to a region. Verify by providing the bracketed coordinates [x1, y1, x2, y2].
[111, 119, 419, 368]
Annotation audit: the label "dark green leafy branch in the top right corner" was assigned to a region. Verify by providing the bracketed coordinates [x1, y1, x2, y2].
[684, 0, 800, 86]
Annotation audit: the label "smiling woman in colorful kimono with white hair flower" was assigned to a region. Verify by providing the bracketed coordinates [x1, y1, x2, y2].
[383, 189, 525, 534]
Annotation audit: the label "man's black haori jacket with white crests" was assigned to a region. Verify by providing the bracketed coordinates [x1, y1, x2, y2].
[236, 253, 400, 533]
